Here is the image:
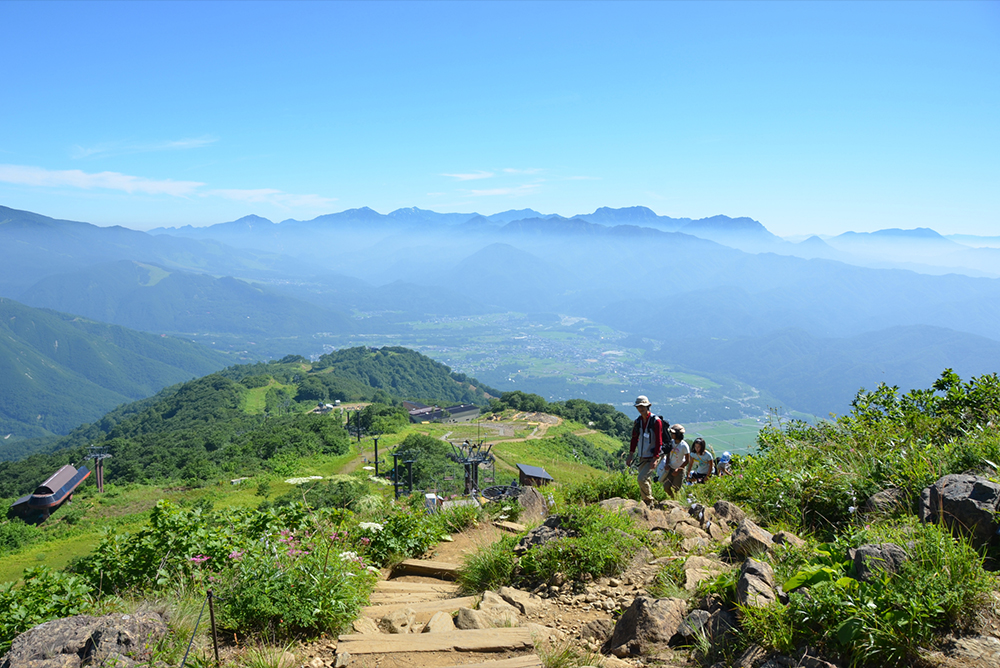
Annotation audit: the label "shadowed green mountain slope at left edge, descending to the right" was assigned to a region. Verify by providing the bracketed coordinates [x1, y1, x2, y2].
[0, 298, 227, 446]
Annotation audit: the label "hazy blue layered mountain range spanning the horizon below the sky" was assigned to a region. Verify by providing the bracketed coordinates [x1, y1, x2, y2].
[0, 207, 1000, 440]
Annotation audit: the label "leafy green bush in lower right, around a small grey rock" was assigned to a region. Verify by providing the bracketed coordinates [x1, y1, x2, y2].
[733, 521, 996, 666]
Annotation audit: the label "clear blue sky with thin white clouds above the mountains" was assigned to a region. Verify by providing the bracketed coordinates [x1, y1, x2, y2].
[0, 0, 1000, 235]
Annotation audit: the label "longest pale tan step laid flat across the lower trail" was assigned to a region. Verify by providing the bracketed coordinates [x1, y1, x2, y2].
[337, 627, 534, 656]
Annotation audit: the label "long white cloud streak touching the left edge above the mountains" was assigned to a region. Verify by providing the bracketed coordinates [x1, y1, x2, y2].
[0, 165, 205, 197]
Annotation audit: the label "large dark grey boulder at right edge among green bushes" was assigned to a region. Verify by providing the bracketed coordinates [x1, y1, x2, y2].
[920, 473, 1000, 546]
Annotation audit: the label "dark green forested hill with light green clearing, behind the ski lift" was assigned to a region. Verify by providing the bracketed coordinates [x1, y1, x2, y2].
[0, 348, 498, 497]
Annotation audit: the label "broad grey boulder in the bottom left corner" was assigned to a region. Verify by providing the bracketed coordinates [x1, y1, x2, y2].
[0, 612, 167, 668]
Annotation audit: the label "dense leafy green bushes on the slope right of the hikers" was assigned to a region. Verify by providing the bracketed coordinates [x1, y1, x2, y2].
[708, 370, 1000, 540]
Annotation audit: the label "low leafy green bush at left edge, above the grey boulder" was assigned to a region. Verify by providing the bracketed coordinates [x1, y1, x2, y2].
[0, 566, 92, 655]
